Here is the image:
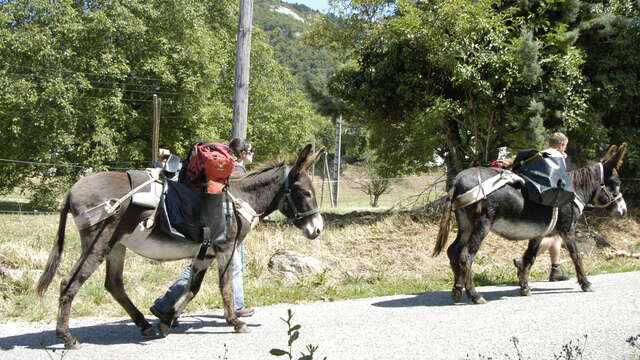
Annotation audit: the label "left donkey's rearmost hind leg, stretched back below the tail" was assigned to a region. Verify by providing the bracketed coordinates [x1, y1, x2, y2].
[56, 228, 115, 349]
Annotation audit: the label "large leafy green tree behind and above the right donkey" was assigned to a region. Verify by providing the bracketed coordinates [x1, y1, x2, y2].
[314, 0, 586, 184]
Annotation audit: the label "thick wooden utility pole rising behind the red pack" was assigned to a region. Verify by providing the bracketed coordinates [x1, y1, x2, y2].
[231, 0, 253, 139]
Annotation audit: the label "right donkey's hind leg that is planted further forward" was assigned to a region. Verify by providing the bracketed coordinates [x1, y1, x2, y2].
[459, 209, 490, 304]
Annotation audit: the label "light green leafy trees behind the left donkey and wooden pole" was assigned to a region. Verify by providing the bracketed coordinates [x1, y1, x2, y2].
[0, 0, 318, 205]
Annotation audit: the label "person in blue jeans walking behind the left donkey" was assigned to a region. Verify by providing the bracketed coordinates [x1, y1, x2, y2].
[149, 138, 255, 326]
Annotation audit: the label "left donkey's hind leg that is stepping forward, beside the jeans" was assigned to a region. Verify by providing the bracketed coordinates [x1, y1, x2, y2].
[104, 244, 157, 336]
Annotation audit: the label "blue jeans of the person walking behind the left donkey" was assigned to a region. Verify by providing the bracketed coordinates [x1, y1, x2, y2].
[153, 244, 245, 312]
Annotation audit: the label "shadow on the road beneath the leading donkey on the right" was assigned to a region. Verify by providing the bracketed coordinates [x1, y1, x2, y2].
[372, 285, 580, 307]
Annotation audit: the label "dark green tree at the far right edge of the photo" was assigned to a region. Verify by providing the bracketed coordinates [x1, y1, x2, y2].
[570, 0, 640, 177]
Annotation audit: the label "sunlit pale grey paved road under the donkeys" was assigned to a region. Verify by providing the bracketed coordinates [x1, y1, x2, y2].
[0, 272, 640, 360]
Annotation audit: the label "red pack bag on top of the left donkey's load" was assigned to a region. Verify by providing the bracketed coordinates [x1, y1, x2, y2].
[184, 142, 235, 194]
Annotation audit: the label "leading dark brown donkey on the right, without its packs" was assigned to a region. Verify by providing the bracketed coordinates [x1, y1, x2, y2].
[433, 144, 627, 304]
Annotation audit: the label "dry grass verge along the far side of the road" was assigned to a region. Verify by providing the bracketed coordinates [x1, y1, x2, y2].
[0, 205, 640, 321]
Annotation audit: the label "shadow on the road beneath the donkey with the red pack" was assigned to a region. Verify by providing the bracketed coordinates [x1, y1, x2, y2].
[0, 315, 260, 350]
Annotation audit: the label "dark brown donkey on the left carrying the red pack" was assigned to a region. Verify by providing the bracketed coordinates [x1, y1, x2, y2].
[37, 145, 325, 348]
